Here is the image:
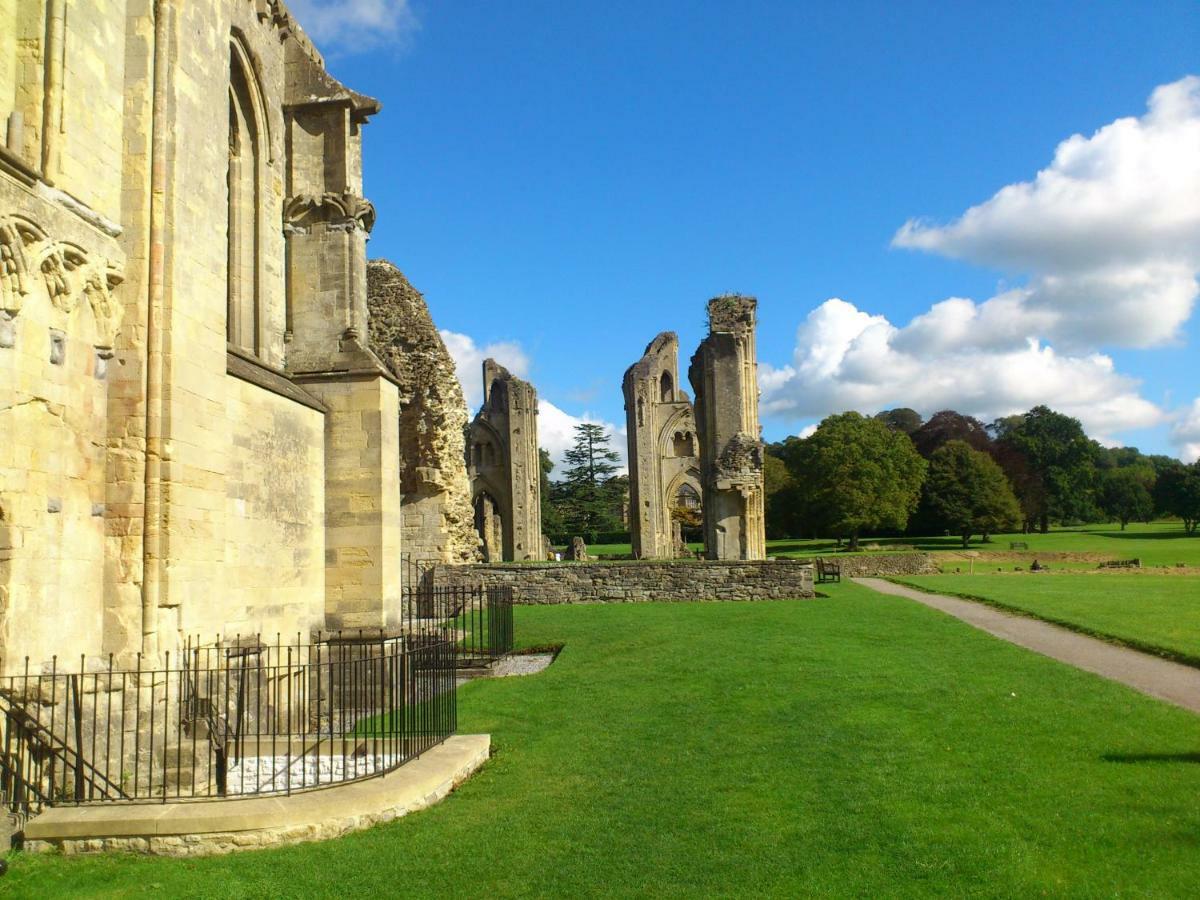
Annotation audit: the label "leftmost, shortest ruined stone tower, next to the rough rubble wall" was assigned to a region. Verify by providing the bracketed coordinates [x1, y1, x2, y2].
[467, 359, 542, 563]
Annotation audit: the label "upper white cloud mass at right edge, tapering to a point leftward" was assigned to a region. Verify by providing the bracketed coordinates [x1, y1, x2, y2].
[893, 76, 1200, 350]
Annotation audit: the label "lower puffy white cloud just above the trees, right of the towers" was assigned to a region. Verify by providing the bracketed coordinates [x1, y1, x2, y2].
[760, 299, 1166, 438]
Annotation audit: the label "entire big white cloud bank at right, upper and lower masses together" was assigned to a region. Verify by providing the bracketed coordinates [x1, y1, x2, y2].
[760, 77, 1200, 456]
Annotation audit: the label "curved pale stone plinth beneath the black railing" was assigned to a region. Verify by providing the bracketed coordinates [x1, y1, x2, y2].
[24, 734, 491, 856]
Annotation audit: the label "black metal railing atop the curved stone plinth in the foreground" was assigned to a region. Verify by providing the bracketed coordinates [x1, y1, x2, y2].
[0, 631, 457, 816]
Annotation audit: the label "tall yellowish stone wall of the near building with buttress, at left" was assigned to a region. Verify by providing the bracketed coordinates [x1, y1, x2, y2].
[0, 0, 400, 671]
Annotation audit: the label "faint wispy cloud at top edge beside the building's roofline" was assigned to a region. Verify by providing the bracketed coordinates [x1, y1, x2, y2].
[288, 0, 420, 56]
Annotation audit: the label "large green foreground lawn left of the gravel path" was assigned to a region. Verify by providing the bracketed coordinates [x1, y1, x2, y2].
[9, 583, 1200, 898]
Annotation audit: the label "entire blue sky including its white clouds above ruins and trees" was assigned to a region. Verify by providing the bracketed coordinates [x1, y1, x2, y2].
[292, 0, 1200, 457]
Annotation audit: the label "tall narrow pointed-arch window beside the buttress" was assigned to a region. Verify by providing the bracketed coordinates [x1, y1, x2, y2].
[226, 42, 264, 355]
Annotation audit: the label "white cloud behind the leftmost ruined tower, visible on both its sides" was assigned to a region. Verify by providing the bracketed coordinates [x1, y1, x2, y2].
[440, 329, 625, 478]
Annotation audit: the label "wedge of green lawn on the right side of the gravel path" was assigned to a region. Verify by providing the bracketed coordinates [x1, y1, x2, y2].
[898, 574, 1200, 665]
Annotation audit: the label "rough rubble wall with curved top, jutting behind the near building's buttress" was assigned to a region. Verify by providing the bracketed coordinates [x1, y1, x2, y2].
[367, 259, 480, 563]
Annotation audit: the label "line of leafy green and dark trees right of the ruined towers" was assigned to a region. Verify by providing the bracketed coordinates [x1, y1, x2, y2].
[764, 406, 1200, 547]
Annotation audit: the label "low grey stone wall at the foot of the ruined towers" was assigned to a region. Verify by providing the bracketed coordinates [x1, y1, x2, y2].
[433, 559, 814, 605]
